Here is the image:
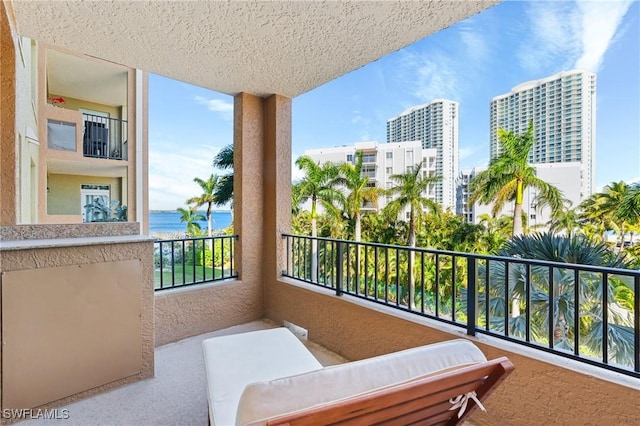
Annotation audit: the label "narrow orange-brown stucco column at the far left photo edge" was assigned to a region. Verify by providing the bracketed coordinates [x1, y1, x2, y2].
[0, 5, 17, 225]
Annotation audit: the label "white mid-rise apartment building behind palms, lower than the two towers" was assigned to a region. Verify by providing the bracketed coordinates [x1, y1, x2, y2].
[304, 141, 437, 219]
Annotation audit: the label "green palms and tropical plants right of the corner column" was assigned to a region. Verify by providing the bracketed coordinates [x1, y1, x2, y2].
[292, 146, 640, 365]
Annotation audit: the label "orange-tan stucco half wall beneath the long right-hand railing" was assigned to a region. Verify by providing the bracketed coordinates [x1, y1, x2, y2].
[265, 280, 640, 425]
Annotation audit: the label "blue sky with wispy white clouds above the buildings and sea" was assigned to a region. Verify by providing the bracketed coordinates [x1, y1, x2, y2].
[149, 0, 640, 210]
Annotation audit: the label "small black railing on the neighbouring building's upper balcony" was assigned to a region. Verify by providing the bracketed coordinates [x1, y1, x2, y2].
[82, 113, 127, 160]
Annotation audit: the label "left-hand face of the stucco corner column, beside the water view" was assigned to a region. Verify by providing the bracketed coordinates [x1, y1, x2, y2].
[233, 93, 267, 290]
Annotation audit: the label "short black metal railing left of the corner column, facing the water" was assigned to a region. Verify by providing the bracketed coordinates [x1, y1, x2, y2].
[154, 235, 238, 291]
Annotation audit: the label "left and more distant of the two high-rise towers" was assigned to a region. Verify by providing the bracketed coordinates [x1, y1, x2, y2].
[387, 99, 459, 210]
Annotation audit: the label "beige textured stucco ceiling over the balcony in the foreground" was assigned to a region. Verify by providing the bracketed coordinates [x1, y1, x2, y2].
[9, 0, 499, 97]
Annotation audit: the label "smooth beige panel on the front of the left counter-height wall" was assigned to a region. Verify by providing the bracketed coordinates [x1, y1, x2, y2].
[1, 259, 144, 409]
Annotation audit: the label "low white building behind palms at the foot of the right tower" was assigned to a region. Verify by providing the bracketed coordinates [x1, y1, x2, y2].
[456, 161, 582, 231]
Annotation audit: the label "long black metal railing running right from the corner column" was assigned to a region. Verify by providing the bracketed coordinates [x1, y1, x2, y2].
[282, 234, 640, 378]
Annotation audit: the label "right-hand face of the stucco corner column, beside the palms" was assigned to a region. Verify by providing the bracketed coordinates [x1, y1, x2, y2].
[263, 95, 291, 284]
